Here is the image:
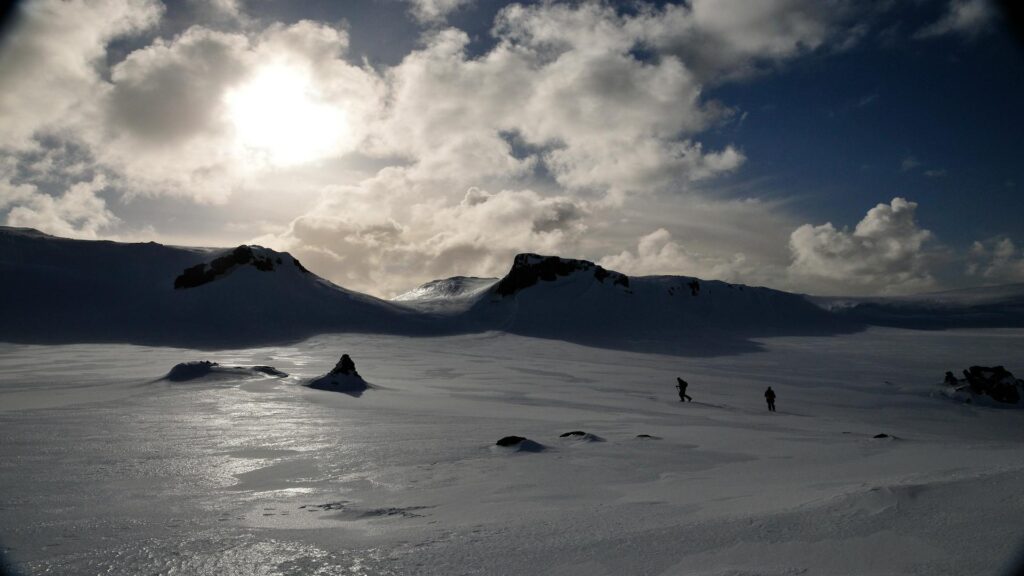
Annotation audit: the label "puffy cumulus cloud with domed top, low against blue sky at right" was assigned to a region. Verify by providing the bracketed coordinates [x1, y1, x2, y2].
[788, 198, 935, 295]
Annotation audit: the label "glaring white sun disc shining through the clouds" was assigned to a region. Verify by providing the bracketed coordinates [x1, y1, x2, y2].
[224, 65, 349, 166]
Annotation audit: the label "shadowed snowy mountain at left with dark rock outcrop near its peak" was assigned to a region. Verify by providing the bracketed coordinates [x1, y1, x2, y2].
[0, 228, 432, 346]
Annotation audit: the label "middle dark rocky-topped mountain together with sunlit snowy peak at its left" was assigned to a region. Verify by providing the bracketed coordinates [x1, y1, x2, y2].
[400, 254, 860, 354]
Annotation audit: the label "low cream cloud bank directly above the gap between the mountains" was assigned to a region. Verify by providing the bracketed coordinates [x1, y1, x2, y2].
[255, 169, 587, 296]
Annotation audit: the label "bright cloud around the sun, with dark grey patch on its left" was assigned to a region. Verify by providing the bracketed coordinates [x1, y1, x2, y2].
[91, 20, 383, 202]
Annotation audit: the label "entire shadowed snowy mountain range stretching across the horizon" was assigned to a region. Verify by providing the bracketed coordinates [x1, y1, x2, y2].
[6, 228, 1024, 355]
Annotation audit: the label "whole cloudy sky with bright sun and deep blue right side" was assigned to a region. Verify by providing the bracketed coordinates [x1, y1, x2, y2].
[0, 0, 1024, 297]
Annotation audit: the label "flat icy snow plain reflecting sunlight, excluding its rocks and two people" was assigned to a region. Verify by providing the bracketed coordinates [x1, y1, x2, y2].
[0, 328, 1024, 576]
